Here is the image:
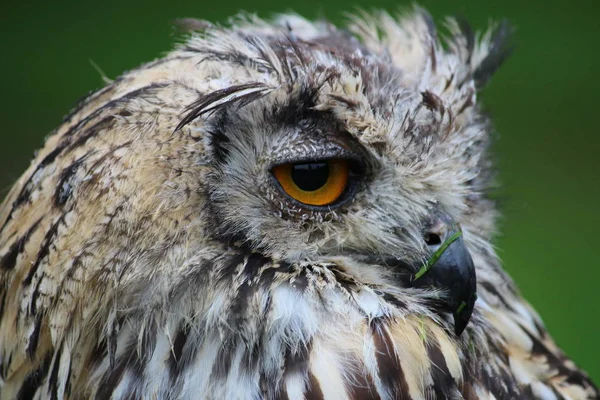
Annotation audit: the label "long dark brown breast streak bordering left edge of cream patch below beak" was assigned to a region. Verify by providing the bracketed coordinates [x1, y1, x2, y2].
[370, 319, 411, 400]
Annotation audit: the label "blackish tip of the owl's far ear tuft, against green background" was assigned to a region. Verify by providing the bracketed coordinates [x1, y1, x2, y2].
[473, 21, 514, 88]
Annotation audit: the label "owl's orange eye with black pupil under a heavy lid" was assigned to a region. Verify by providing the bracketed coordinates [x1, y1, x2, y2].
[273, 159, 349, 206]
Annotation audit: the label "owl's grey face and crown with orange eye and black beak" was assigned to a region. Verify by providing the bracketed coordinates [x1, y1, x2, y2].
[159, 10, 508, 331]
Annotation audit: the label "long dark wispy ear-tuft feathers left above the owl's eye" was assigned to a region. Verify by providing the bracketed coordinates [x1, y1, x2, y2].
[175, 82, 269, 132]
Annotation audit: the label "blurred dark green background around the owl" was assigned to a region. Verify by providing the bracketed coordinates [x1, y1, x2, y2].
[0, 0, 600, 383]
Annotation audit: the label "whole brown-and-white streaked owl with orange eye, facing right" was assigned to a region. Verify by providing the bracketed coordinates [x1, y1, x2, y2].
[0, 6, 600, 400]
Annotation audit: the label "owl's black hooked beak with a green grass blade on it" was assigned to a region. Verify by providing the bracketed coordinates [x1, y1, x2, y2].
[410, 216, 477, 335]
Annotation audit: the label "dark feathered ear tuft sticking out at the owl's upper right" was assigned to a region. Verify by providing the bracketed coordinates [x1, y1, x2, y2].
[472, 21, 514, 89]
